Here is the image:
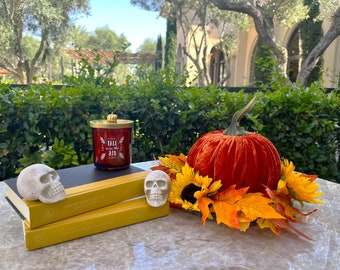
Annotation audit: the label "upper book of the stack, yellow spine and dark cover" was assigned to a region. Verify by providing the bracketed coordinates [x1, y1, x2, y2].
[5, 165, 148, 229]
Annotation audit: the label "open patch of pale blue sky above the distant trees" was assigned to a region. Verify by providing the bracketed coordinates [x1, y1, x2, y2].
[76, 0, 166, 52]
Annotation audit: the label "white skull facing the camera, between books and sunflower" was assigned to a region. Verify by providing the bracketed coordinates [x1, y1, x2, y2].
[144, 170, 171, 207]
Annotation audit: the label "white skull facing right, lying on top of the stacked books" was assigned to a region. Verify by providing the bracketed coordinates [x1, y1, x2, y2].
[17, 164, 66, 203]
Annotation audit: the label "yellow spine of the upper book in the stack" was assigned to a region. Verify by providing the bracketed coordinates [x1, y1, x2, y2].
[28, 172, 147, 229]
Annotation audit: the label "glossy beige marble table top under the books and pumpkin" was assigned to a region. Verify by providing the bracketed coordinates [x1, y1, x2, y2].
[0, 162, 340, 270]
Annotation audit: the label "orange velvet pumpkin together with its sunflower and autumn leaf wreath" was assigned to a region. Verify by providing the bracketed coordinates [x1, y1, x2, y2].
[151, 98, 323, 240]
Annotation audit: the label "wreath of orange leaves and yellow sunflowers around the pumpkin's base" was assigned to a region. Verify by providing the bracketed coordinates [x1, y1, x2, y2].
[152, 154, 323, 240]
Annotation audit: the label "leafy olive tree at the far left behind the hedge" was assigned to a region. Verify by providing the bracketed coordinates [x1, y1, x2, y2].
[0, 0, 88, 83]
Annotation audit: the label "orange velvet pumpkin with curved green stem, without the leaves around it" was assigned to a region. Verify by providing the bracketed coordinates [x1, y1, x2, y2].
[187, 98, 281, 192]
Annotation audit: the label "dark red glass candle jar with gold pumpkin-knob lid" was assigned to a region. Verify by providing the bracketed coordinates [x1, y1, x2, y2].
[90, 114, 133, 170]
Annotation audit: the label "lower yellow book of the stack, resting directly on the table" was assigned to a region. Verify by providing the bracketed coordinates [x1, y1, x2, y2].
[23, 197, 169, 250]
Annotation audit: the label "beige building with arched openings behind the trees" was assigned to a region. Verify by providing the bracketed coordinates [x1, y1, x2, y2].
[176, 7, 340, 88]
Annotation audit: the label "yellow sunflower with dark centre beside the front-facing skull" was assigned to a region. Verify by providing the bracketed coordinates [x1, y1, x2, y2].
[169, 163, 222, 211]
